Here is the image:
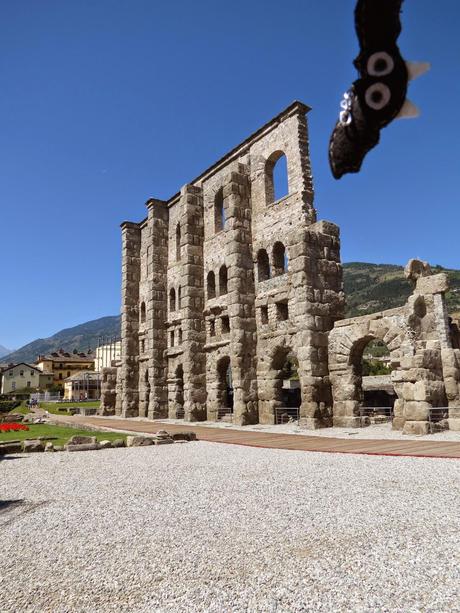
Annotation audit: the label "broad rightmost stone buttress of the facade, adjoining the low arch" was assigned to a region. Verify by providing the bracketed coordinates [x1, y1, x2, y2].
[290, 221, 345, 429]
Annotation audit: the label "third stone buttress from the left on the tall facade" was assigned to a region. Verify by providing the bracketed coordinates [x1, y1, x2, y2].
[180, 185, 206, 421]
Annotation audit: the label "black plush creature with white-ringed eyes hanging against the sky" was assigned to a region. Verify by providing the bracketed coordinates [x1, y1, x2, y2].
[329, 0, 429, 179]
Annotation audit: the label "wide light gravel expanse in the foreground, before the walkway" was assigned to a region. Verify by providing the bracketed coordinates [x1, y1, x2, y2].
[0, 442, 460, 613]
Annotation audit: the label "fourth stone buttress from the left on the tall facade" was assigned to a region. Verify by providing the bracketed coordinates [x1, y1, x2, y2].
[223, 164, 258, 425]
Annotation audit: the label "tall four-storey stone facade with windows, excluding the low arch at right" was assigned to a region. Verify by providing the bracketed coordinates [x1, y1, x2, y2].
[117, 103, 344, 427]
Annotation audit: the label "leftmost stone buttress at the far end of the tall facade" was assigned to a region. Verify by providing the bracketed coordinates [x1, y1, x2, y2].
[120, 221, 141, 417]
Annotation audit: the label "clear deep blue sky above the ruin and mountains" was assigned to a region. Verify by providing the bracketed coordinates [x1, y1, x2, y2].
[0, 0, 460, 347]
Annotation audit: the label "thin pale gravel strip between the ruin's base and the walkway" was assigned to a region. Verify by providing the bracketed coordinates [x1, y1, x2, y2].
[127, 417, 460, 442]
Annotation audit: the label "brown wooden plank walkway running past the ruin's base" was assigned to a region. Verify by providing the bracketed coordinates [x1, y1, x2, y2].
[53, 415, 460, 458]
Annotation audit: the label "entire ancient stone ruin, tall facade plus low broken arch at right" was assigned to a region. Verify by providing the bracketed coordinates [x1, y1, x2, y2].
[101, 102, 460, 433]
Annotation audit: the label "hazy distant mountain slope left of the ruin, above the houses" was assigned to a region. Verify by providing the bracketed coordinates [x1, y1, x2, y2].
[2, 315, 120, 363]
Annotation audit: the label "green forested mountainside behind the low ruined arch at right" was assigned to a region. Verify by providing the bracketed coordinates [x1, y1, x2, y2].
[343, 262, 460, 317]
